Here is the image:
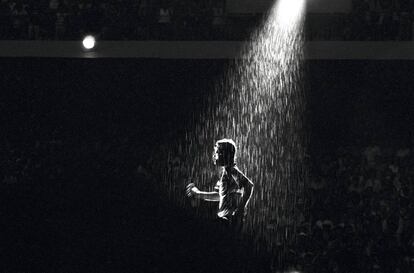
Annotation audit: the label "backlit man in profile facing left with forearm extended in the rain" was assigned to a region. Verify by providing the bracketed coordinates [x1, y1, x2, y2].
[187, 139, 254, 232]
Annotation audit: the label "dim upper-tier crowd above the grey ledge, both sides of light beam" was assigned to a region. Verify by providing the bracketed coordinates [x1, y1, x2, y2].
[0, 0, 414, 41]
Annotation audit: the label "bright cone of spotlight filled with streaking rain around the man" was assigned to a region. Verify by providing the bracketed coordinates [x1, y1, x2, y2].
[158, 0, 307, 266]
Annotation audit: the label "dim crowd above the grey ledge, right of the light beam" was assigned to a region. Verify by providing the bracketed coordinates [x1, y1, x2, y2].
[308, 0, 414, 41]
